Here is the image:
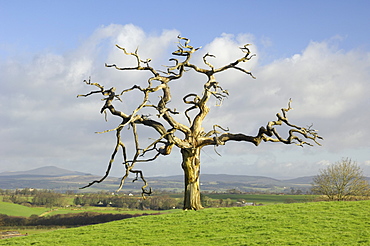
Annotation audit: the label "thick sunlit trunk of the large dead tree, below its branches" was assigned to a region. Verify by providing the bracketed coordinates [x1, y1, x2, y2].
[181, 148, 203, 210]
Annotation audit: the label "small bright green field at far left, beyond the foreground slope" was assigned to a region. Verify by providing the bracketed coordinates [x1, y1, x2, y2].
[0, 202, 49, 217]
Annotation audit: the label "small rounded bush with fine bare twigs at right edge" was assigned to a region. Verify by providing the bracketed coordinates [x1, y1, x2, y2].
[312, 158, 370, 201]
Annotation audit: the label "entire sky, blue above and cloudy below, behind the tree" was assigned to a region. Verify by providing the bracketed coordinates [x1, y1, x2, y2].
[0, 0, 370, 179]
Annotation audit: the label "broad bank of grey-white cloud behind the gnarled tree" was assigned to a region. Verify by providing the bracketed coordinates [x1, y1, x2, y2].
[0, 24, 370, 177]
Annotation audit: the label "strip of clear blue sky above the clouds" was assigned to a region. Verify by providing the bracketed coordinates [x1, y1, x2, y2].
[0, 1, 370, 58]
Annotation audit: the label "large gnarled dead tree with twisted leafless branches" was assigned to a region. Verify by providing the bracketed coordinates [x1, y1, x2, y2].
[78, 36, 322, 210]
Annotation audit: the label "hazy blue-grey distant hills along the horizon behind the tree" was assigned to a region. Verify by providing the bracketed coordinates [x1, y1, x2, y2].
[0, 166, 312, 192]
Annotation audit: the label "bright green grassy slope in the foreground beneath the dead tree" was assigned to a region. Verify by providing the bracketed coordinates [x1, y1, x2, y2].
[0, 201, 370, 246]
